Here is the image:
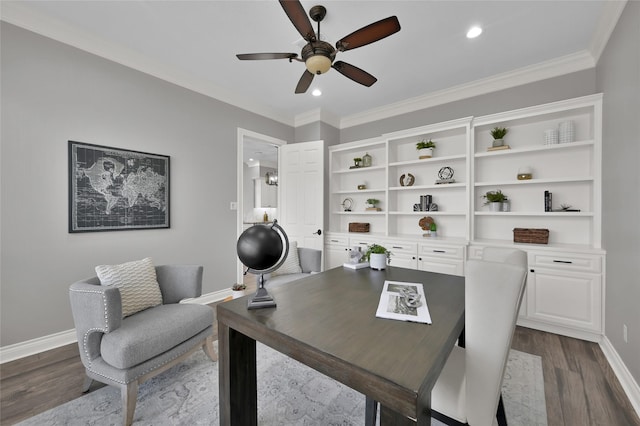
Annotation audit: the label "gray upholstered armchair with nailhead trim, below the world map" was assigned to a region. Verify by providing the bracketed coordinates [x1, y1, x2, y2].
[69, 265, 217, 425]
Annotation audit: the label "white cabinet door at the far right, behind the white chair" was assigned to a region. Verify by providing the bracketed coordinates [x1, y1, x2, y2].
[527, 267, 602, 332]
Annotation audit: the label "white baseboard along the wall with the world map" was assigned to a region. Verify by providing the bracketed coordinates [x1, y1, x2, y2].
[0, 289, 231, 364]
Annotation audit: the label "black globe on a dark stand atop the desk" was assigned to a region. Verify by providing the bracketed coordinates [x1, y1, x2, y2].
[236, 220, 289, 309]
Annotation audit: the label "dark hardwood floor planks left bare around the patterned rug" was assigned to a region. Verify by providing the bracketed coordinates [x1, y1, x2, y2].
[0, 314, 640, 426]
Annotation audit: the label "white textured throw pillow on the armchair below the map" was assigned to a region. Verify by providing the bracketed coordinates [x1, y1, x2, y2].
[96, 257, 162, 318]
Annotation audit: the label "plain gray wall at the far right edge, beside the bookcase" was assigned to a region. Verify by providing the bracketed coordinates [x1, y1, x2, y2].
[596, 1, 640, 383]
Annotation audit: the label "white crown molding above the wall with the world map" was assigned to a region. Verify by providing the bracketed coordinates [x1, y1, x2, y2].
[0, 2, 294, 126]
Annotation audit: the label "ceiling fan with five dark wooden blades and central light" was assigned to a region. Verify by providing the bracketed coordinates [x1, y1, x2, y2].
[236, 0, 400, 93]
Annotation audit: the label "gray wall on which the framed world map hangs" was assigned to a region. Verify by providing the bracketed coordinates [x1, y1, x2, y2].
[0, 22, 294, 346]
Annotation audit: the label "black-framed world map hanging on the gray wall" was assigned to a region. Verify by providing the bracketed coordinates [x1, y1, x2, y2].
[69, 141, 169, 233]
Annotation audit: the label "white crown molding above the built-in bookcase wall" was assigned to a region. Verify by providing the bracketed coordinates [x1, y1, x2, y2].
[339, 50, 595, 129]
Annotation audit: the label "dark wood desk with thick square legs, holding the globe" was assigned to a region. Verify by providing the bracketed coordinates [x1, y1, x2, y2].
[217, 267, 464, 426]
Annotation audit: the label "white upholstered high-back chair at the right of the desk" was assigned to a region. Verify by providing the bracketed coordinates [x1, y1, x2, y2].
[366, 248, 527, 426]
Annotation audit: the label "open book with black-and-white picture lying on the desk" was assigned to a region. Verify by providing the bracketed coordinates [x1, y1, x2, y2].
[376, 281, 431, 324]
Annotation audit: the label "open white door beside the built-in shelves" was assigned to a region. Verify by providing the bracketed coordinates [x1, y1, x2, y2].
[278, 141, 324, 260]
